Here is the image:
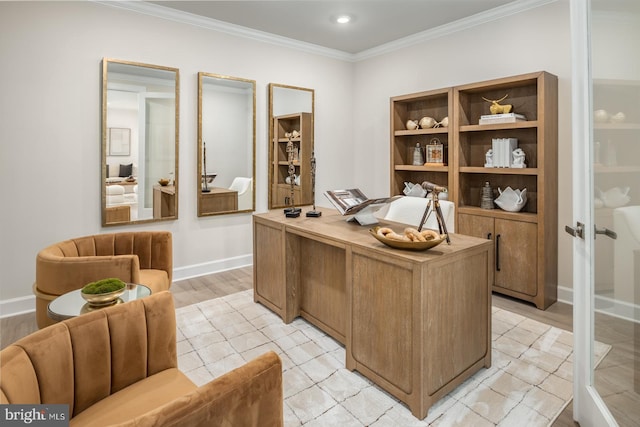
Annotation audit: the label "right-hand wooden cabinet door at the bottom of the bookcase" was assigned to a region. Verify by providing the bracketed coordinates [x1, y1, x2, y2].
[495, 219, 538, 296]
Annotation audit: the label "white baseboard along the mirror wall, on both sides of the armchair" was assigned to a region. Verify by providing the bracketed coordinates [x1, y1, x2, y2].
[0, 255, 253, 319]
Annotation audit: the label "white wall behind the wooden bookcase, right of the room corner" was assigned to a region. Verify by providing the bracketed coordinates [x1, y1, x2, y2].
[352, 1, 573, 287]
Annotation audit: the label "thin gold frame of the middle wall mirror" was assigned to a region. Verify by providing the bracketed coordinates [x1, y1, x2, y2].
[196, 71, 256, 217]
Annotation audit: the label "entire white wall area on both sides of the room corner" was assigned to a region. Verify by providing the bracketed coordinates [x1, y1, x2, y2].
[0, 1, 571, 312]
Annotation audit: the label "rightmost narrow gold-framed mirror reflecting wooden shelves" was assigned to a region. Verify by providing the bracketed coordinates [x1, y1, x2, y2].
[269, 83, 315, 209]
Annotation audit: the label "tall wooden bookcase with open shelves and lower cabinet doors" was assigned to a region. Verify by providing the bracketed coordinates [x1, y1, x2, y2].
[391, 72, 558, 309]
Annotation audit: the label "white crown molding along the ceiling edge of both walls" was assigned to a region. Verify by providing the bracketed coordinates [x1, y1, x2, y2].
[89, 0, 566, 62]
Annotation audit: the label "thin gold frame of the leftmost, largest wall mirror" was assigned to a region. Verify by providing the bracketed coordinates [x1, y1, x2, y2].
[100, 58, 180, 227]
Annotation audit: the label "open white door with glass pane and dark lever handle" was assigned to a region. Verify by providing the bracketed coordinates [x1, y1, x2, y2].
[567, 0, 640, 427]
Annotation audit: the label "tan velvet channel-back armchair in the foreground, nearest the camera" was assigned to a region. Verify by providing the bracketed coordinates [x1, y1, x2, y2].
[0, 291, 283, 427]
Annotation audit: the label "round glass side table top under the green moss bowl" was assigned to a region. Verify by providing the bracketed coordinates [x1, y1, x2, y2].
[47, 283, 151, 321]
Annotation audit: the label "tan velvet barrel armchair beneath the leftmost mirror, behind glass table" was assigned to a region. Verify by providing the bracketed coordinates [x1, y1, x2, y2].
[33, 231, 173, 328]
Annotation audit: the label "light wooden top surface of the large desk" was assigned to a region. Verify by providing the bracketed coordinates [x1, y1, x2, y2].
[254, 208, 493, 262]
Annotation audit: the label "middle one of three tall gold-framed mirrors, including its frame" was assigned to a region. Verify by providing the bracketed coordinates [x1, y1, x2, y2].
[197, 72, 256, 216]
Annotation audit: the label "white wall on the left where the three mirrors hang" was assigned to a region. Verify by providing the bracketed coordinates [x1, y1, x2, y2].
[0, 2, 353, 308]
